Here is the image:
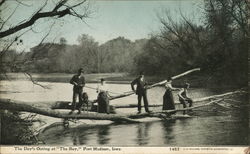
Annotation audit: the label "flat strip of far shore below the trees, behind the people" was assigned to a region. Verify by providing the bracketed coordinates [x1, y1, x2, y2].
[0, 73, 242, 88]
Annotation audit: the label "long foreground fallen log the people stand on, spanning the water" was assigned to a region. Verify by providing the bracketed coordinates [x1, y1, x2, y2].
[0, 99, 227, 123]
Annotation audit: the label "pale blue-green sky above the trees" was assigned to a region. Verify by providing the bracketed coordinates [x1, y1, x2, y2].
[1, 0, 203, 51]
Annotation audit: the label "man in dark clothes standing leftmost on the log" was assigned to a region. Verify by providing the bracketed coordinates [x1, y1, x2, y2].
[69, 68, 85, 114]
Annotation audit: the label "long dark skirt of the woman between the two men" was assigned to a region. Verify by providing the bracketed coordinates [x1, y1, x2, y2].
[97, 92, 109, 113]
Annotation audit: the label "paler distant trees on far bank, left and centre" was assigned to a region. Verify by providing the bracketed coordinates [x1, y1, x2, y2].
[3, 34, 147, 73]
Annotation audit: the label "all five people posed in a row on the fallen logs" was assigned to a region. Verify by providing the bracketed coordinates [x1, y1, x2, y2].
[69, 68, 193, 114]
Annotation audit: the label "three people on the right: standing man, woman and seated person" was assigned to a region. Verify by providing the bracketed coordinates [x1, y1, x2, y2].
[131, 72, 193, 114]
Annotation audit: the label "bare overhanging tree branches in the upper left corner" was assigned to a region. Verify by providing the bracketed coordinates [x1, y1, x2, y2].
[0, 0, 92, 84]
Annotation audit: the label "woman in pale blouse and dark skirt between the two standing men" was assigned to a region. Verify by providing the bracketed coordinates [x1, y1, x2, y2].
[96, 79, 110, 114]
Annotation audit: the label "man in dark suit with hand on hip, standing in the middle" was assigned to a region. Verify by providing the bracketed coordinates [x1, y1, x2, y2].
[131, 72, 151, 114]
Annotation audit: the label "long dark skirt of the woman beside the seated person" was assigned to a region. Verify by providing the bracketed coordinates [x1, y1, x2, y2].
[162, 89, 175, 110]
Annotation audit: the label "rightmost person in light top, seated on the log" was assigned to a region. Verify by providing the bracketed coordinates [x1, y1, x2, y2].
[178, 83, 193, 114]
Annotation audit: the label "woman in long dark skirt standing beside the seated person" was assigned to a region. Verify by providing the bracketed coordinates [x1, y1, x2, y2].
[162, 77, 179, 110]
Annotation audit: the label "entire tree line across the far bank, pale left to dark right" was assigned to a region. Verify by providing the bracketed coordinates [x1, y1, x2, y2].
[1, 0, 249, 84]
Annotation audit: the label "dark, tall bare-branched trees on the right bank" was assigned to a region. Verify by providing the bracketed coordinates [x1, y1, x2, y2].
[135, 0, 249, 85]
